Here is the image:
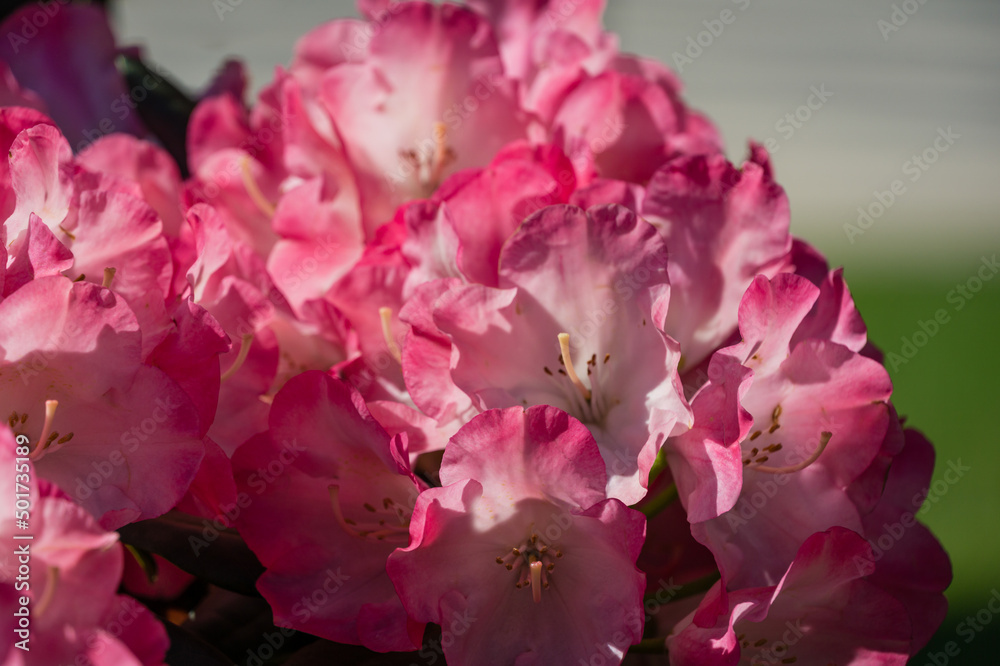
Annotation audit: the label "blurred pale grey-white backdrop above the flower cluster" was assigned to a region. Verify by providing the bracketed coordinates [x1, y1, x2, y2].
[115, 0, 1000, 272]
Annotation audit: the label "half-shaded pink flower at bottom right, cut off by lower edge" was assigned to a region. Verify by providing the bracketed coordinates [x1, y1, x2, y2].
[667, 527, 910, 666]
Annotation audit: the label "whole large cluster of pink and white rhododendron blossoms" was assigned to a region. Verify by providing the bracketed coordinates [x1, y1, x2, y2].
[0, 0, 951, 665]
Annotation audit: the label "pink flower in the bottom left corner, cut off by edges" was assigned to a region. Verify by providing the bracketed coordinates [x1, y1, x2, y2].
[0, 425, 168, 666]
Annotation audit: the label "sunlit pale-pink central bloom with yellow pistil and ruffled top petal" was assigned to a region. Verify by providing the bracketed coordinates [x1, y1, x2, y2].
[404, 206, 690, 502]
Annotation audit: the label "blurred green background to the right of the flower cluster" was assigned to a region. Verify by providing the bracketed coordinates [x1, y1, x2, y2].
[846, 262, 1000, 666]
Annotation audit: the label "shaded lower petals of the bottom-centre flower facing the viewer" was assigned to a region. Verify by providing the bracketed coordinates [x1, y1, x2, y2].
[388, 480, 645, 665]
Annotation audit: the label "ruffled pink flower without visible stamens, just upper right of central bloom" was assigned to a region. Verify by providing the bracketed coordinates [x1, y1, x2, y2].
[641, 144, 792, 370]
